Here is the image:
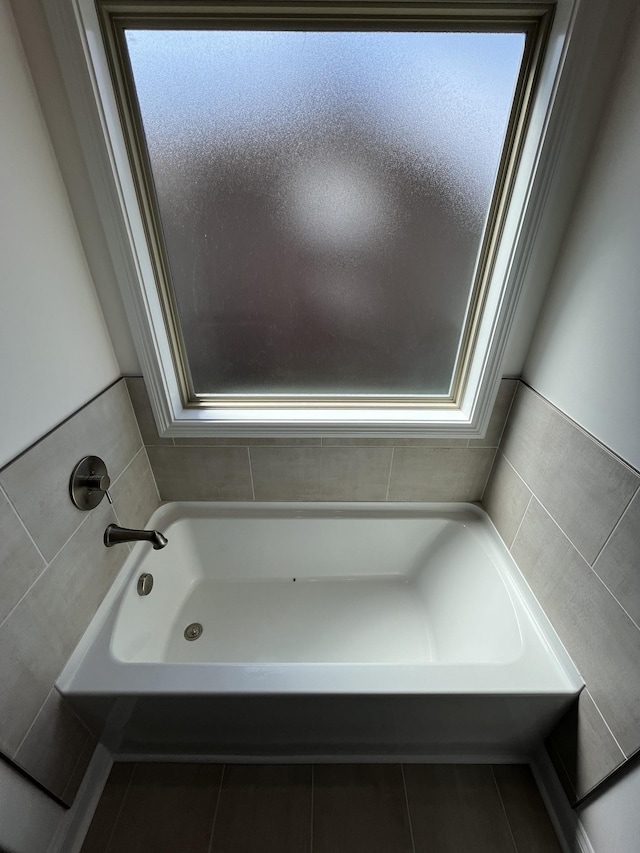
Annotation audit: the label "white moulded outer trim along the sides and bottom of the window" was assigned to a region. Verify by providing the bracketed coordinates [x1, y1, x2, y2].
[45, 0, 580, 439]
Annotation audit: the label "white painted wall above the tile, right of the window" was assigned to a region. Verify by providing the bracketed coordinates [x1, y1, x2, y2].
[524, 6, 640, 468]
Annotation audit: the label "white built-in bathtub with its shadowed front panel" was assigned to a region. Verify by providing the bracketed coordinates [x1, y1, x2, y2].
[58, 503, 583, 758]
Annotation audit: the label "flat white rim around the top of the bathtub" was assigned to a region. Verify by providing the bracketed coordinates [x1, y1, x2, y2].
[56, 501, 584, 697]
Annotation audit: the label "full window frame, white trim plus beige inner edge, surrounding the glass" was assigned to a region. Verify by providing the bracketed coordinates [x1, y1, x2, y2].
[49, 0, 575, 439]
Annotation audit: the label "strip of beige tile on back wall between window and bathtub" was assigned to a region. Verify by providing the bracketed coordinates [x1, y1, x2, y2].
[127, 377, 517, 501]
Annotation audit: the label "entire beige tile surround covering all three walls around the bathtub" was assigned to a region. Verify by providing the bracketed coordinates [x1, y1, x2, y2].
[8, 378, 624, 802]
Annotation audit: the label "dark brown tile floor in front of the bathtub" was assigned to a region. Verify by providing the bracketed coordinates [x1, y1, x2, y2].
[82, 764, 560, 853]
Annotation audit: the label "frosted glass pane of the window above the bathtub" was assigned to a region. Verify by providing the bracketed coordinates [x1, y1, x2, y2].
[125, 28, 525, 397]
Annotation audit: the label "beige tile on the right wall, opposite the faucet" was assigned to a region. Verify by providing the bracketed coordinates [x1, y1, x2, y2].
[483, 383, 640, 801]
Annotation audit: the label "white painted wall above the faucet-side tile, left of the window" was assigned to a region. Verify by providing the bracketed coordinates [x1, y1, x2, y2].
[0, 0, 120, 466]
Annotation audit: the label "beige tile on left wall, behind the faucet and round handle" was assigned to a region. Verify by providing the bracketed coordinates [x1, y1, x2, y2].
[0, 380, 159, 803]
